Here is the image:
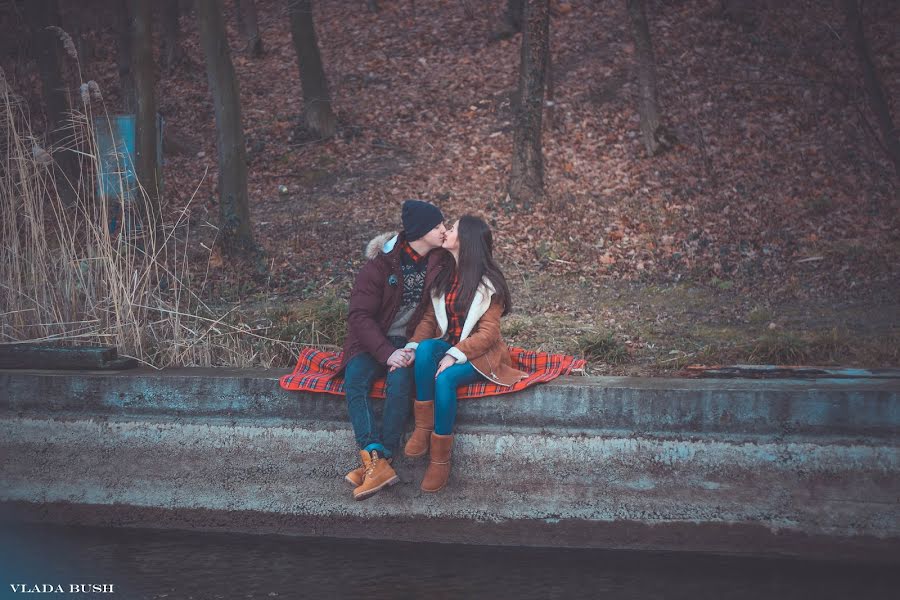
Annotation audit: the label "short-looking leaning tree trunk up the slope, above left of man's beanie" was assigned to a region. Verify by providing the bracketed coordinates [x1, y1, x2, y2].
[288, 0, 337, 138]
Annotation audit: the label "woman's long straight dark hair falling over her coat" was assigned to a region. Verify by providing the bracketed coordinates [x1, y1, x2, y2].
[431, 215, 512, 315]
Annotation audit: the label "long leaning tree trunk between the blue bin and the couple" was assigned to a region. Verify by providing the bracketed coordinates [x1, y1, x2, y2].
[196, 0, 256, 256]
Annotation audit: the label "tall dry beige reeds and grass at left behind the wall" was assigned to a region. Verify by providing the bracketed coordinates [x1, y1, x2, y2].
[0, 50, 304, 367]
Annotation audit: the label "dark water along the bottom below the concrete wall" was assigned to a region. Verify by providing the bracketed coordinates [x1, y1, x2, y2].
[0, 525, 900, 600]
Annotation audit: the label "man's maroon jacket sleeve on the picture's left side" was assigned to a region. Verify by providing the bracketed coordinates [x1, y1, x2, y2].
[347, 261, 396, 364]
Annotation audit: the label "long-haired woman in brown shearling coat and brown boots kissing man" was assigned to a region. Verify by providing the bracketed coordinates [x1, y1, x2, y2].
[404, 216, 526, 492]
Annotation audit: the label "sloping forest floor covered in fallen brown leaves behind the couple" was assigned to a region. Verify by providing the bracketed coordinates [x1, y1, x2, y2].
[3, 0, 900, 375]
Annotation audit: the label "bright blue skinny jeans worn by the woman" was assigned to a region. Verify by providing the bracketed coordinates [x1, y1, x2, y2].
[413, 339, 484, 435]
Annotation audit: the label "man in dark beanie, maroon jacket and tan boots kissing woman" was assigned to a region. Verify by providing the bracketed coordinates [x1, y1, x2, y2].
[342, 200, 446, 500]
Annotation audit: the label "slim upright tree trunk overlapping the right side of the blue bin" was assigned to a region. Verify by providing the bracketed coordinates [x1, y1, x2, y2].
[128, 0, 161, 229]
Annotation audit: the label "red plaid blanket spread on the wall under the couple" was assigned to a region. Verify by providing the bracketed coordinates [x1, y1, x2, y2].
[279, 348, 585, 399]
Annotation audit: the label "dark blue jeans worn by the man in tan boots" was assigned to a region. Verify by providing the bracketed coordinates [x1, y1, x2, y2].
[344, 337, 413, 457]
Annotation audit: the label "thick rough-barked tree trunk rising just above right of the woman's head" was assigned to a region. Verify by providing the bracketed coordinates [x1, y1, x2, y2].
[509, 0, 550, 208]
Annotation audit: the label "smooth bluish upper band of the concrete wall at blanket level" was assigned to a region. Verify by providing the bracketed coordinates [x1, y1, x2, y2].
[0, 369, 900, 439]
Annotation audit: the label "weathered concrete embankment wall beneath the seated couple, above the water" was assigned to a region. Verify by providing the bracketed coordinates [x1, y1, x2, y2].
[0, 369, 900, 561]
